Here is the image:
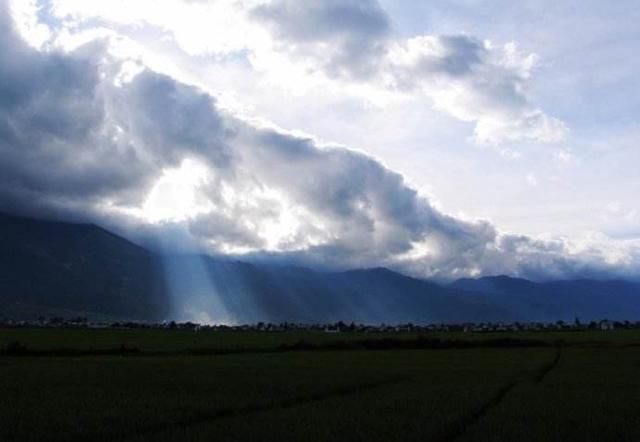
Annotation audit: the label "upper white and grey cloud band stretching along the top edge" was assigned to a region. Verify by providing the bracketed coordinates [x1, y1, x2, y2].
[41, 0, 568, 145]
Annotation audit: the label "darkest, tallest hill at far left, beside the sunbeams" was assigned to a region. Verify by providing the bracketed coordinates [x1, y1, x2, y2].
[0, 215, 169, 319]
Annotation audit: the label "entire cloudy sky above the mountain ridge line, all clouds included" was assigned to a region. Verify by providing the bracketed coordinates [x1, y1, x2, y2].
[0, 0, 640, 279]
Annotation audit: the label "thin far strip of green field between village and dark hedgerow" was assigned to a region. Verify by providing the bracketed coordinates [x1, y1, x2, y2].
[0, 327, 640, 352]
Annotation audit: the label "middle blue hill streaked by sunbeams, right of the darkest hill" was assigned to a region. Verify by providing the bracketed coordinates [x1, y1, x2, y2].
[170, 257, 504, 323]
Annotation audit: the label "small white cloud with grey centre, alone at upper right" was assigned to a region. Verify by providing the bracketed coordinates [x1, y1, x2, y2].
[390, 35, 567, 144]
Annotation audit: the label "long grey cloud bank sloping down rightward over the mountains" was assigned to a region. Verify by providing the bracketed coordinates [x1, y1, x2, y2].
[0, 2, 640, 278]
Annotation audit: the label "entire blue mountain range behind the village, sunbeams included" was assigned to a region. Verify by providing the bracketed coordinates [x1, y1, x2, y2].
[0, 215, 640, 323]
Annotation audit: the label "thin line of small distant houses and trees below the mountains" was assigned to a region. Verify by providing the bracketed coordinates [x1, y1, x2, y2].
[0, 317, 624, 333]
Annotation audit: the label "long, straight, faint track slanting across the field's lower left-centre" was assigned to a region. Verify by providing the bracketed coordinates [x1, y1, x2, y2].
[102, 377, 412, 441]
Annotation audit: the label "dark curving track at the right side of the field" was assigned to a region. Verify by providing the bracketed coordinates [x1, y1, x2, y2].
[440, 347, 562, 442]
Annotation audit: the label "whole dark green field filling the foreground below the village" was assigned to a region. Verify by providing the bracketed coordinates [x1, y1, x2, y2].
[0, 328, 640, 441]
